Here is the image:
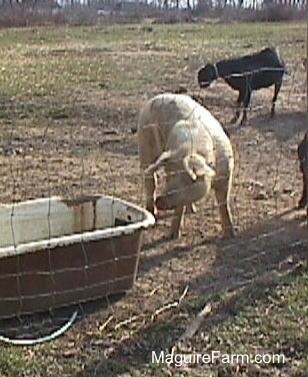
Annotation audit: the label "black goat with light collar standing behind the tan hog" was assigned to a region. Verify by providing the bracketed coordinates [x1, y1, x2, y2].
[198, 48, 286, 123]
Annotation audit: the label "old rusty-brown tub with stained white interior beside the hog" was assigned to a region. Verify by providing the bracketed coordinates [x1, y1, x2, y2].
[0, 195, 155, 318]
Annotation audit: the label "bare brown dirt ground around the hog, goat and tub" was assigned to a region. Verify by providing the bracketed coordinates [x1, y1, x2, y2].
[0, 22, 308, 376]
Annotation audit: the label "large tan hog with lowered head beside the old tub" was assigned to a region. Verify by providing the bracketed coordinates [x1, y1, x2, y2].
[138, 93, 234, 238]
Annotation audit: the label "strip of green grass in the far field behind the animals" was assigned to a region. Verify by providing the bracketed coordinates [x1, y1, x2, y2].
[0, 23, 305, 134]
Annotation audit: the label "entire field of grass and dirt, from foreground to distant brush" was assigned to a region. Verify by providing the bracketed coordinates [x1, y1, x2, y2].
[0, 23, 308, 377]
